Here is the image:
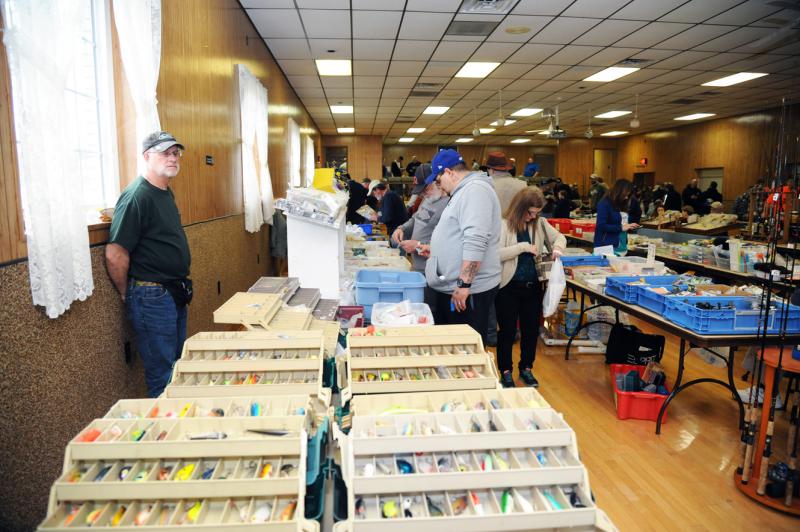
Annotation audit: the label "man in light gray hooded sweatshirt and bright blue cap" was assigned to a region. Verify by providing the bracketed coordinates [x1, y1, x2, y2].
[423, 150, 501, 342]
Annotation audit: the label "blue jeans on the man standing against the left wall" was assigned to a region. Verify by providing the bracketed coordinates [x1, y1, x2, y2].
[125, 281, 187, 397]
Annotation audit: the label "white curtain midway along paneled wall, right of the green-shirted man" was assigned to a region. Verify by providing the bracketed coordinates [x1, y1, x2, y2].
[236, 65, 275, 233]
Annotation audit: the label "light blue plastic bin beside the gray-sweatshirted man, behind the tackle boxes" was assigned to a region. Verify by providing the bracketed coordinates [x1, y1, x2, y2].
[356, 270, 426, 316]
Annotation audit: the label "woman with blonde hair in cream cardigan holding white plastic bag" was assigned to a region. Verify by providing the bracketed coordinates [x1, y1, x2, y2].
[495, 187, 567, 388]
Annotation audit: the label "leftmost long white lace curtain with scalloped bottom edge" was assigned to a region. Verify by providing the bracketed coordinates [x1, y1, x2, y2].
[0, 0, 94, 318]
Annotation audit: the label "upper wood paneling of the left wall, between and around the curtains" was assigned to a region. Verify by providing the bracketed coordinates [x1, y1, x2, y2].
[0, 0, 318, 262]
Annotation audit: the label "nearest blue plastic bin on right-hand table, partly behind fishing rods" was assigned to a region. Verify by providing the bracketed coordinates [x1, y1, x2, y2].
[664, 296, 800, 334]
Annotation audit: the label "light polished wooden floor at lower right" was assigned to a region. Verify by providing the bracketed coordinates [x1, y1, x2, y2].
[490, 316, 800, 531]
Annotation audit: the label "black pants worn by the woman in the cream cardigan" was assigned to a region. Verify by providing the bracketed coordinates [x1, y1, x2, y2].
[495, 281, 542, 374]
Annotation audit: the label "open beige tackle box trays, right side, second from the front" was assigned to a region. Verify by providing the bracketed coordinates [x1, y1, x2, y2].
[342, 325, 498, 402]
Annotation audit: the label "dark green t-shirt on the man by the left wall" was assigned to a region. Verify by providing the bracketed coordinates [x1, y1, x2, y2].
[108, 176, 192, 283]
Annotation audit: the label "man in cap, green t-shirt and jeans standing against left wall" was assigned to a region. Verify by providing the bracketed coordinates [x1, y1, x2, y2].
[105, 131, 192, 397]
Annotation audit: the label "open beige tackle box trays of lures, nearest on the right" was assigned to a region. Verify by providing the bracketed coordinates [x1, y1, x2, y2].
[334, 390, 598, 532]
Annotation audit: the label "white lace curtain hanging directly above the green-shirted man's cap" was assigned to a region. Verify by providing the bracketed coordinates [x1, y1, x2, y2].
[114, 0, 161, 175]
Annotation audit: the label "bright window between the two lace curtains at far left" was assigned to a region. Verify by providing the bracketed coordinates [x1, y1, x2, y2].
[65, 0, 119, 223]
